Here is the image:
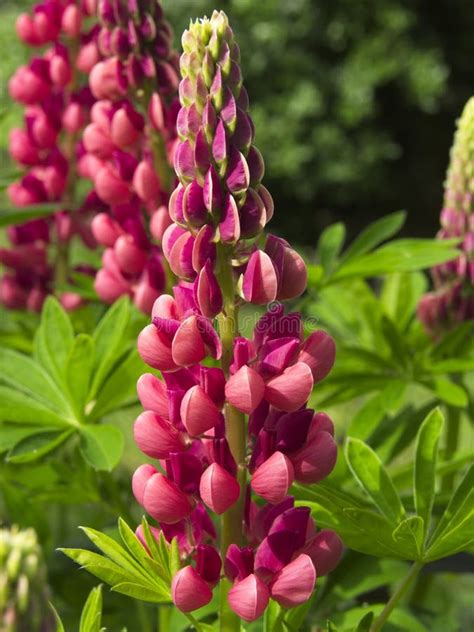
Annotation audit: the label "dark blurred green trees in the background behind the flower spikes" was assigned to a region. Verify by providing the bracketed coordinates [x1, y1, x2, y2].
[0, 0, 474, 245]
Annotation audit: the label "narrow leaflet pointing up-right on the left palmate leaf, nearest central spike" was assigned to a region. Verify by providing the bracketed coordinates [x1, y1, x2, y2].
[90, 297, 130, 399]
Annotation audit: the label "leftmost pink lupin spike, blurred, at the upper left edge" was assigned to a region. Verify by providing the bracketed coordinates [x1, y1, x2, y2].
[0, 0, 99, 311]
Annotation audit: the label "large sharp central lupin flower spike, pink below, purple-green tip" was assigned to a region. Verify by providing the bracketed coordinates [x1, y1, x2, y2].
[133, 11, 342, 630]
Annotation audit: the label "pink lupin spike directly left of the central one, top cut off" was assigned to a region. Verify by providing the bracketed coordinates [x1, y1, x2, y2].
[83, 0, 178, 313]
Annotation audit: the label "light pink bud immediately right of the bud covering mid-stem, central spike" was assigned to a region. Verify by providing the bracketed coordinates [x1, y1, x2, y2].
[265, 362, 313, 413]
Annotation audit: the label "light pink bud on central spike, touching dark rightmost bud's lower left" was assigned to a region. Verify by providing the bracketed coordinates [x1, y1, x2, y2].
[251, 452, 294, 505]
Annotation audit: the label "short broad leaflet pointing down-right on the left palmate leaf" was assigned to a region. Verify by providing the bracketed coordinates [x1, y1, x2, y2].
[79, 424, 124, 472]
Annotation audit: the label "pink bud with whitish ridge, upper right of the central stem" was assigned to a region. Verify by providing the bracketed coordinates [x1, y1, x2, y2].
[242, 250, 278, 305]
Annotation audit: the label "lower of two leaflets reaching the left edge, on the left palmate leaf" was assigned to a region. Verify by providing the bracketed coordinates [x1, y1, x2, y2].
[0, 386, 70, 428]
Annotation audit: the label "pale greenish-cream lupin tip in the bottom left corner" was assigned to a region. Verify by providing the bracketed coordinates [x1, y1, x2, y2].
[0, 527, 54, 632]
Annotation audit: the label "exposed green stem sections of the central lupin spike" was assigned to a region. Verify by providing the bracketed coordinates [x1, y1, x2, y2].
[217, 244, 247, 632]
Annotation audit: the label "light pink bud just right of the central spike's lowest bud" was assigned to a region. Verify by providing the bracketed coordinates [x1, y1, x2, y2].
[270, 553, 316, 608]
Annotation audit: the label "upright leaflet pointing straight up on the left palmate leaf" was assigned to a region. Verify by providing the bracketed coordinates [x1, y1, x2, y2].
[34, 296, 74, 385]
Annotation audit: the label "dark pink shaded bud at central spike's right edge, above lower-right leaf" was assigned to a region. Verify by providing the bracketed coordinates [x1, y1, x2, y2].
[291, 430, 337, 483]
